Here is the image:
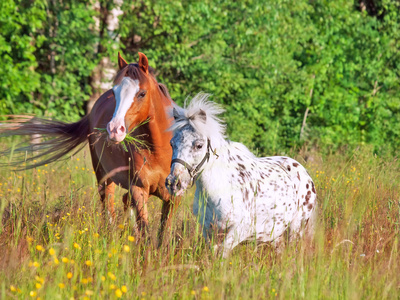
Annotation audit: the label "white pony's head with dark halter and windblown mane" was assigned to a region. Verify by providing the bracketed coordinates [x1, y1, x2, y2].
[165, 93, 225, 196]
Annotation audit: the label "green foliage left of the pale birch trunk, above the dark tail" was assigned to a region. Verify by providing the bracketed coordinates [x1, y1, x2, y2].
[0, 0, 117, 120]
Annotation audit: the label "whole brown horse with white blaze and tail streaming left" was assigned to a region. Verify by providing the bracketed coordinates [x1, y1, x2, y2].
[2, 53, 179, 242]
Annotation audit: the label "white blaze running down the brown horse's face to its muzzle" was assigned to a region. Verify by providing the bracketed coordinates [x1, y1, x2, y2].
[107, 77, 140, 142]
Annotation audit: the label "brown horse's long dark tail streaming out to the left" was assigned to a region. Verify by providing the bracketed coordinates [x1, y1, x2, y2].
[0, 116, 90, 170]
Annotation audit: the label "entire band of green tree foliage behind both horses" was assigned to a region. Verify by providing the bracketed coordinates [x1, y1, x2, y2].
[0, 0, 400, 154]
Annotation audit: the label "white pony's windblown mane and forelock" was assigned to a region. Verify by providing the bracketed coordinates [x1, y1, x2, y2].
[169, 93, 226, 147]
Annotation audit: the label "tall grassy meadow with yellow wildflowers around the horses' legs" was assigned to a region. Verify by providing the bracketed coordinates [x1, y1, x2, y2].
[0, 144, 400, 299]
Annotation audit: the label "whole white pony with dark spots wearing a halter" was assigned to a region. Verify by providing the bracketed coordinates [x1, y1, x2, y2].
[166, 94, 316, 257]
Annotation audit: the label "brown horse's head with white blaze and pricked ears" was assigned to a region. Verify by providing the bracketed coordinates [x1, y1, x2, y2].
[107, 52, 162, 143]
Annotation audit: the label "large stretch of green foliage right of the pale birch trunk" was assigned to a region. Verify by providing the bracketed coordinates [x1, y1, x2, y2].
[117, 1, 400, 153]
